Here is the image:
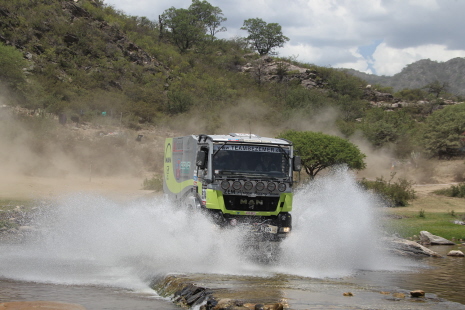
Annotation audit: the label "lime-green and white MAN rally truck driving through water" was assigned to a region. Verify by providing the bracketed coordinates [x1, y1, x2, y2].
[163, 133, 301, 247]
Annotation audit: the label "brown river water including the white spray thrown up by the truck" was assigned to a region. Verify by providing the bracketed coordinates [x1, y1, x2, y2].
[0, 171, 465, 309]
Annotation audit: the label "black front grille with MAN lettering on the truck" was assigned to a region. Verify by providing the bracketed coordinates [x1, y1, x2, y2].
[223, 195, 279, 212]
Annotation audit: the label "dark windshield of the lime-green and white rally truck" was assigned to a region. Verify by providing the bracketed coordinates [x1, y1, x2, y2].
[212, 144, 289, 178]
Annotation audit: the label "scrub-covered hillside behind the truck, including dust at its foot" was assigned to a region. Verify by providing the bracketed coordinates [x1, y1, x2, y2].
[0, 0, 463, 188]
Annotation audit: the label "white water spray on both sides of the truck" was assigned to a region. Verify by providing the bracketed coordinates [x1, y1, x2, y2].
[0, 170, 406, 290]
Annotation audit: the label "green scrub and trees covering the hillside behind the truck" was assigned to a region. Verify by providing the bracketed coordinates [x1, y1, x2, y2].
[0, 0, 465, 171]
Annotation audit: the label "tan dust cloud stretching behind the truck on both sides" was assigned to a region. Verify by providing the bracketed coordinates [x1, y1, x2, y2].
[0, 89, 450, 198]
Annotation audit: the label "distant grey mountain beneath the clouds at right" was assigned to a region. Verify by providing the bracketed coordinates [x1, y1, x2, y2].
[345, 57, 465, 96]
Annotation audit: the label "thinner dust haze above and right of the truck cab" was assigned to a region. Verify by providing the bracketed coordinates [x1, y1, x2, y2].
[163, 99, 437, 183]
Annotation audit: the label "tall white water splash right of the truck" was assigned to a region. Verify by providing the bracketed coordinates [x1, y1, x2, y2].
[281, 168, 395, 277]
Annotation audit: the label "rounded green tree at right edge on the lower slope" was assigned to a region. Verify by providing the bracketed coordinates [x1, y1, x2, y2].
[421, 103, 465, 156]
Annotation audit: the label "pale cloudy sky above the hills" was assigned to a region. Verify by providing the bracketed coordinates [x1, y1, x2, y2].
[104, 0, 465, 76]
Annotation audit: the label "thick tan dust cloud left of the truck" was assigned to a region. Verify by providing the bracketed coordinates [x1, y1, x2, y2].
[0, 97, 157, 199]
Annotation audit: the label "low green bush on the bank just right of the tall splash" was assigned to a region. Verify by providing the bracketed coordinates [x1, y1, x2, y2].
[360, 174, 415, 207]
